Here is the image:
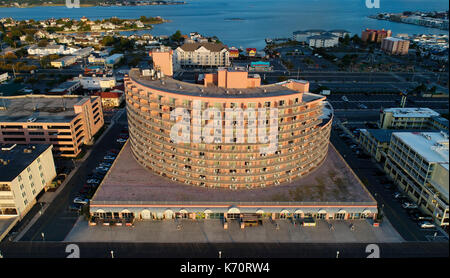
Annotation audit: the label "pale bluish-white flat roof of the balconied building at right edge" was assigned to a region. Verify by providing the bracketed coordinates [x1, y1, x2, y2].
[393, 132, 449, 170]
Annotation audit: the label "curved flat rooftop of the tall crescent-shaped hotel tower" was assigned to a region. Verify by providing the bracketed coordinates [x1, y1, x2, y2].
[129, 69, 323, 100]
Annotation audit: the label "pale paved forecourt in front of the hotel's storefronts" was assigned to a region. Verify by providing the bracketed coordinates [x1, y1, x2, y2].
[65, 218, 403, 243]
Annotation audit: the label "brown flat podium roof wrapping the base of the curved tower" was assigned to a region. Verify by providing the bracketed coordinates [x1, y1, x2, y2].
[91, 142, 376, 205]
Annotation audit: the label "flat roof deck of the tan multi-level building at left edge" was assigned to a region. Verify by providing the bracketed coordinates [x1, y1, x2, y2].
[0, 95, 91, 123]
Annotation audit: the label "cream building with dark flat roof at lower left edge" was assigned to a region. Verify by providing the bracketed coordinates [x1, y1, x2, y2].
[0, 144, 56, 240]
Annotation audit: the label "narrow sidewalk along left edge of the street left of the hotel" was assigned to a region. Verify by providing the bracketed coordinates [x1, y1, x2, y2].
[13, 108, 125, 242]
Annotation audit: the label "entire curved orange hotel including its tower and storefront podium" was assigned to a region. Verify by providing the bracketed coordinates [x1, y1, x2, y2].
[89, 49, 377, 225]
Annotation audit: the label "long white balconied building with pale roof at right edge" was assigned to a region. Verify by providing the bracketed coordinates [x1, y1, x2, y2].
[384, 132, 449, 226]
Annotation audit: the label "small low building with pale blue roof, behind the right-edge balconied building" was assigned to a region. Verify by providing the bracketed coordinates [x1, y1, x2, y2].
[379, 108, 448, 132]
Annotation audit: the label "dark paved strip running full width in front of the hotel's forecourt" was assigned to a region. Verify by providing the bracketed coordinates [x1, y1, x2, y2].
[0, 242, 449, 259]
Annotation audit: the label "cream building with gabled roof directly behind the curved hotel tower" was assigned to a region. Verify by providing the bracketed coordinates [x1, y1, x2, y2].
[173, 42, 230, 67]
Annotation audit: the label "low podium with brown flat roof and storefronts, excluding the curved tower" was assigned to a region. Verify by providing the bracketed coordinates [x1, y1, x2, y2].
[90, 142, 378, 224]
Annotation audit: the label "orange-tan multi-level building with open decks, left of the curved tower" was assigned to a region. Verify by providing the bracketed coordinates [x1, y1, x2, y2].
[0, 95, 104, 157]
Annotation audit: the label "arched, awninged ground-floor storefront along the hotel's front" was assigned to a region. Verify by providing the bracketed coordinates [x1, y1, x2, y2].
[90, 204, 378, 226]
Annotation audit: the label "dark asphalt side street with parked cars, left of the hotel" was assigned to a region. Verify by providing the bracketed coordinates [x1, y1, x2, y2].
[16, 110, 126, 241]
